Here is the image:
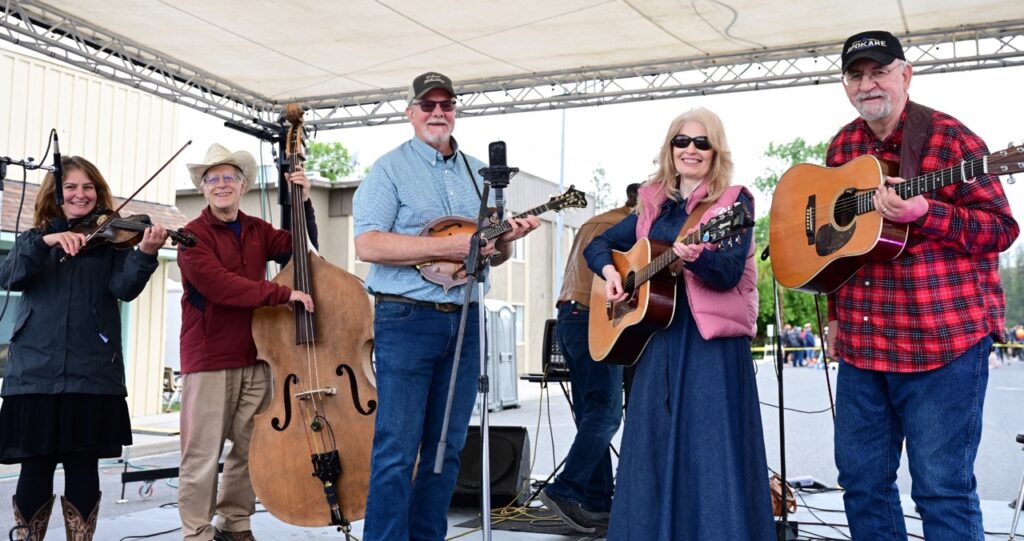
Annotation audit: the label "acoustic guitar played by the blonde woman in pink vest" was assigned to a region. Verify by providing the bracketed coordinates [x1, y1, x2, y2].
[588, 202, 754, 366]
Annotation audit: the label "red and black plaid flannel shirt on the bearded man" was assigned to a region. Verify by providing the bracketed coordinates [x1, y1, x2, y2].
[825, 102, 1020, 372]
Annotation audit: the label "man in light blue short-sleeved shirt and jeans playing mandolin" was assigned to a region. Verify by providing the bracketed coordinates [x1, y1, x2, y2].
[353, 72, 540, 541]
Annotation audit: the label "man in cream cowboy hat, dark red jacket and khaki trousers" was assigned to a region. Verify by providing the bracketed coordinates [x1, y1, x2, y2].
[178, 144, 316, 541]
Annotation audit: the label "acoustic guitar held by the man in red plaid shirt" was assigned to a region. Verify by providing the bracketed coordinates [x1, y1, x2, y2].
[768, 145, 1024, 293]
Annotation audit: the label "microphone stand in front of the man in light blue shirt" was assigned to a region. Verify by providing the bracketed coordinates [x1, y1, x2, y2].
[434, 182, 495, 540]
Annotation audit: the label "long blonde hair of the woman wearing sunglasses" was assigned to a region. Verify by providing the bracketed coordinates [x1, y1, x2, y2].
[638, 108, 732, 203]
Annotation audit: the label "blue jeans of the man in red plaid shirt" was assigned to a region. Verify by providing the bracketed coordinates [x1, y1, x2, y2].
[836, 336, 992, 541]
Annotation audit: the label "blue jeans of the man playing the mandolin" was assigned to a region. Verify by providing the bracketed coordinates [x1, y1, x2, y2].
[362, 301, 480, 541]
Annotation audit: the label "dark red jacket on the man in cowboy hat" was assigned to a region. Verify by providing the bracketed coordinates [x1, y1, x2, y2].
[178, 207, 294, 373]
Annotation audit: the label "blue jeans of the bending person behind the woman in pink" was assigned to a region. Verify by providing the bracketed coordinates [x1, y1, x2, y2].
[546, 302, 623, 512]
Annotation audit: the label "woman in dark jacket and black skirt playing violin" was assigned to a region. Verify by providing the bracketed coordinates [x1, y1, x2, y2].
[0, 157, 168, 540]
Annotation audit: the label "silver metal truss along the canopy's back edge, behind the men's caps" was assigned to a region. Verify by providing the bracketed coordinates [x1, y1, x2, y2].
[313, 19, 1024, 129]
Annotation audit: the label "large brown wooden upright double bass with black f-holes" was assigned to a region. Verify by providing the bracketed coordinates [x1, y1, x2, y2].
[249, 103, 377, 532]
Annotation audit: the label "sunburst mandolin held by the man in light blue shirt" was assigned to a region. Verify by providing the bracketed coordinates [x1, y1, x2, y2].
[416, 185, 587, 292]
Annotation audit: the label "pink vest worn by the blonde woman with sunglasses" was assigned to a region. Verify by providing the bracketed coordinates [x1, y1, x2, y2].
[637, 184, 758, 340]
